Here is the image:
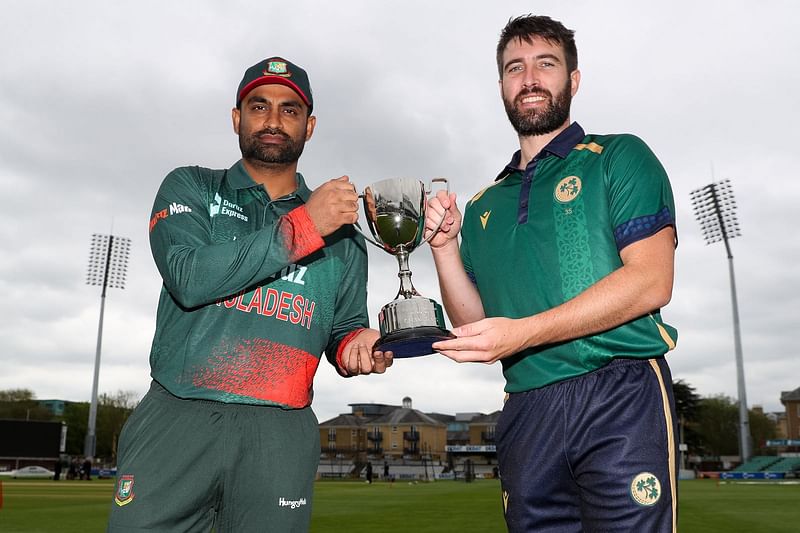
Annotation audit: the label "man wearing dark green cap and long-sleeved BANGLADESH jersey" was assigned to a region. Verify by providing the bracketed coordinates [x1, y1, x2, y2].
[108, 57, 392, 533]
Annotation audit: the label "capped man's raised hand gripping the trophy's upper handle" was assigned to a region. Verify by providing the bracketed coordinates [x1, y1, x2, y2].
[306, 176, 358, 237]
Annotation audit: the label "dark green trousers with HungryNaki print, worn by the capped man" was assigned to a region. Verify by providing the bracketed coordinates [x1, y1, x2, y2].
[108, 382, 320, 533]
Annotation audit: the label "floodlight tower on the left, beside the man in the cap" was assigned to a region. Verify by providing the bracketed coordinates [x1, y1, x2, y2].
[83, 233, 131, 459]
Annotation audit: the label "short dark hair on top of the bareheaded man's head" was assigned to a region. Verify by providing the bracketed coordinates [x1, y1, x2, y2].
[497, 15, 578, 79]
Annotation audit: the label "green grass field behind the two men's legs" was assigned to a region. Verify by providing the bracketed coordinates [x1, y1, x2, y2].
[0, 480, 800, 533]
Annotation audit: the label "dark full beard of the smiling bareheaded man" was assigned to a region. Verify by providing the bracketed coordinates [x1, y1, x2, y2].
[503, 79, 572, 137]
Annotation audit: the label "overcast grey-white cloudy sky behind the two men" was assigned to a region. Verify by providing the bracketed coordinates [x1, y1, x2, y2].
[0, 0, 800, 420]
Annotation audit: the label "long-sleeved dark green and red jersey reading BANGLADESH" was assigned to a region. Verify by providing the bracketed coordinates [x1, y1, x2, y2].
[150, 161, 369, 408]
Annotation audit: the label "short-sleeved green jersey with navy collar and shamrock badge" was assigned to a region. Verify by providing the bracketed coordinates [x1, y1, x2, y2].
[461, 124, 677, 392]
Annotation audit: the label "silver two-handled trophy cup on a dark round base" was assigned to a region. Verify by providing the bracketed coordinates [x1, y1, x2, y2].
[359, 178, 453, 357]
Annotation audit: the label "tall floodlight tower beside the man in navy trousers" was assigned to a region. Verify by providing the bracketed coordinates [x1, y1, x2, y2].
[691, 180, 751, 463]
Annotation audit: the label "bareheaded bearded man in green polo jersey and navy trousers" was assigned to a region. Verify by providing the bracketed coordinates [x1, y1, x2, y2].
[426, 16, 677, 532]
